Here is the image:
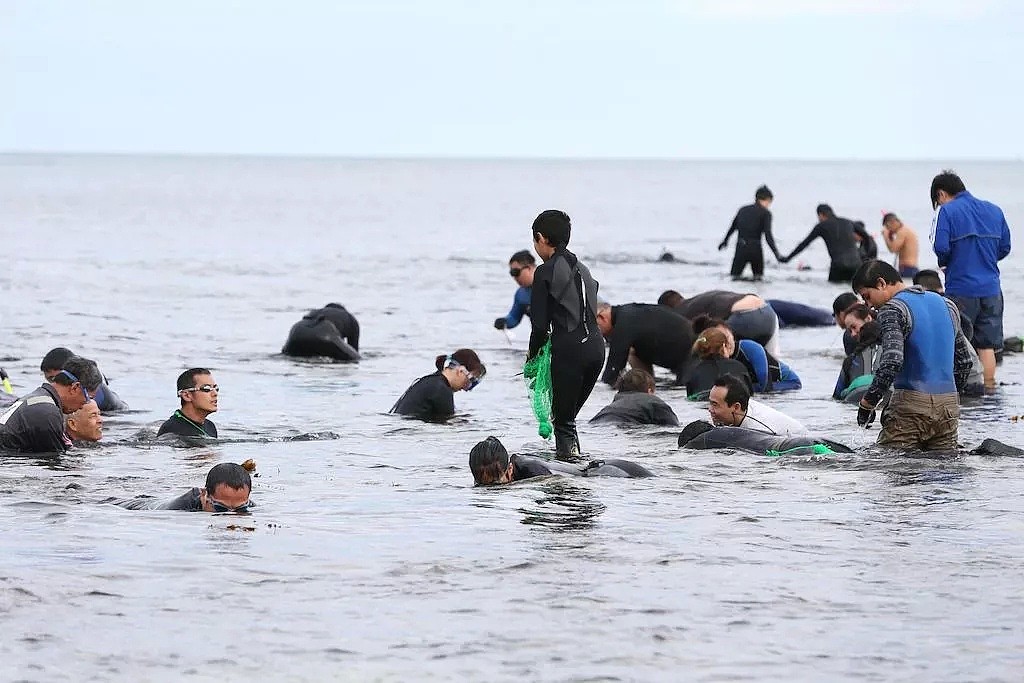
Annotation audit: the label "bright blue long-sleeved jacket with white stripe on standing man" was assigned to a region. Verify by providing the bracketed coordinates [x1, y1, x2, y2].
[932, 190, 1010, 297]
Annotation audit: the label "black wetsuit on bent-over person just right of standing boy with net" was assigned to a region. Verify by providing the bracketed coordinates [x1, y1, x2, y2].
[601, 303, 694, 384]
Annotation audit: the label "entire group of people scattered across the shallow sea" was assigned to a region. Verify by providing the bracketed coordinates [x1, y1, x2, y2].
[0, 172, 1010, 499]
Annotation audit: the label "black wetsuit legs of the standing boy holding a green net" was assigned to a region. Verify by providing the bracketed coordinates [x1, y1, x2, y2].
[551, 325, 604, 456]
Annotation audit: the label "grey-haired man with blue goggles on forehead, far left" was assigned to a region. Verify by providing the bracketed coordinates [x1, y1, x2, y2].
[0, 355, 103, 453]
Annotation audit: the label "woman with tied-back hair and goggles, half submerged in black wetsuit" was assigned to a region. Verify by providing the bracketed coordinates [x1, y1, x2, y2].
[390, 348, 487, 422]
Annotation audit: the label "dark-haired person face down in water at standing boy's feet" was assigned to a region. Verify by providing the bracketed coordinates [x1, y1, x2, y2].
[469, 436, 654, 486]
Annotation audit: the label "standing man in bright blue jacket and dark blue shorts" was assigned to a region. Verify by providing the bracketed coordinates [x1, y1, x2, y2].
[931, 171, 1010, 391]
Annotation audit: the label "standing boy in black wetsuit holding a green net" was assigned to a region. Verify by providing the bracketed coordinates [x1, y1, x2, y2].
[527, 209, 604, 457]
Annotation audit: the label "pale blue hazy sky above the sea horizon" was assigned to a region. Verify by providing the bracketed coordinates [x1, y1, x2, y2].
[0, 0, 1024, 160]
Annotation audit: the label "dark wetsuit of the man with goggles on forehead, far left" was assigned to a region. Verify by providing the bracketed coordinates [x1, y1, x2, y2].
[0, 382, 71, 453]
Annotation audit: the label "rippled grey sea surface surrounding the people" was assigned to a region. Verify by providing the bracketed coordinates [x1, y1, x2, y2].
[0, 156, 1024, 682]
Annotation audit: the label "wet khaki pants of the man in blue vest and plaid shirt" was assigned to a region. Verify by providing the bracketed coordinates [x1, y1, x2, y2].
[879, 389, 959, 451]
